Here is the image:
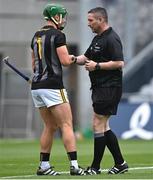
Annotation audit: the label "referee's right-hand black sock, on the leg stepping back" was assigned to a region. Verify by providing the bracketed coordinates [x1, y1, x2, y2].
[104, 130, 124, 164]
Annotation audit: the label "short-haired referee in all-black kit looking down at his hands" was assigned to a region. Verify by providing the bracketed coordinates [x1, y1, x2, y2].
[75, 7, 128, 175]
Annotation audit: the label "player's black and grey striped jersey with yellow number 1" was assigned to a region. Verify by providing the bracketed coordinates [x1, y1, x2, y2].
[31, 26, 66, 89]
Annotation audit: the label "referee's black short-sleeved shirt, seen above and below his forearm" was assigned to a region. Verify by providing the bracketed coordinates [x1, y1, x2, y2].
[84, 27, 124, 87]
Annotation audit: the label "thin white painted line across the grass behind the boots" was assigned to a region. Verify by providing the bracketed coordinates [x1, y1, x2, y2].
[0, 166, 153, 179]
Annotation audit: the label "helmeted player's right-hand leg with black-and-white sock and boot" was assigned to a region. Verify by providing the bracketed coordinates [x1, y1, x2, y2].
[51, 103, 85, 175]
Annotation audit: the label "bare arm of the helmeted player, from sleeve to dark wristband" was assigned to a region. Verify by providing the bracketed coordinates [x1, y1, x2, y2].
[56, 45, 73, 66]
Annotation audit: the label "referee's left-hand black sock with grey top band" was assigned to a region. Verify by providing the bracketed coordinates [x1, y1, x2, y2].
[91, 133, 105, 170]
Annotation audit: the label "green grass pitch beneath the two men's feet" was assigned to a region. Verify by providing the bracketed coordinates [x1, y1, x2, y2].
[0, 139, 153, 179]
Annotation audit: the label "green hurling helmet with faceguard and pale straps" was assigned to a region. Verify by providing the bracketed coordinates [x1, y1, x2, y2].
[43, 4, 67, 29]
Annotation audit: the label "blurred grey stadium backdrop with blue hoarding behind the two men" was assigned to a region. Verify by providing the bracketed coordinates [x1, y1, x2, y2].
[0, 0, 153, 140]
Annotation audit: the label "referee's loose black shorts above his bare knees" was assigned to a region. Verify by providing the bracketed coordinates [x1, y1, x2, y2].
[92, 87, 122, 115]
